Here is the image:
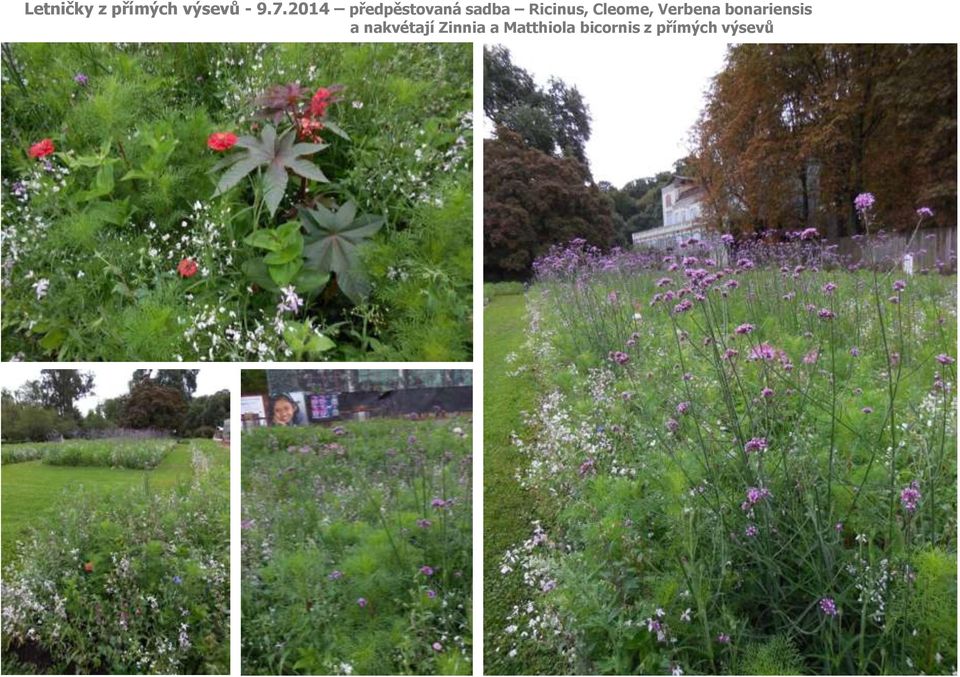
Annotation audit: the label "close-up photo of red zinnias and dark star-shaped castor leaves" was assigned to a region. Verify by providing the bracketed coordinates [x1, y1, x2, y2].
[0, 43, 473, 362]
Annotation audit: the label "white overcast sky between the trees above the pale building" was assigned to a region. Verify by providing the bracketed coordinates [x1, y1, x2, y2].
[488, 39, 727, 188]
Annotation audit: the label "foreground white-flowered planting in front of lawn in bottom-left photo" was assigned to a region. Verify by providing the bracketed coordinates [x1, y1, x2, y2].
[2, 447, 230, 674]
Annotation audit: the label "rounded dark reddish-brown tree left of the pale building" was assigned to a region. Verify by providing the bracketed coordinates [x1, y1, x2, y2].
[483, 127, 614, 279]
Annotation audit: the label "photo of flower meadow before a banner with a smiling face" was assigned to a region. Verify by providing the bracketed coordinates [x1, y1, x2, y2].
[238, 369, 473, 675]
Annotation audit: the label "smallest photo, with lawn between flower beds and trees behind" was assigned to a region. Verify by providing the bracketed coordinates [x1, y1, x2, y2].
[0, 365, 230, 675]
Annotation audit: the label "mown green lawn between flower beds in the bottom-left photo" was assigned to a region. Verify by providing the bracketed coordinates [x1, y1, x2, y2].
[0, 440, 230, 565]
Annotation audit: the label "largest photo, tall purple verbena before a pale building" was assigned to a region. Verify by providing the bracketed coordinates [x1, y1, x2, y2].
[483, 43, 957, 675]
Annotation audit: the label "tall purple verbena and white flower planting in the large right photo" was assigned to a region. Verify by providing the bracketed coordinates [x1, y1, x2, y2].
[485, 203, 957, 675]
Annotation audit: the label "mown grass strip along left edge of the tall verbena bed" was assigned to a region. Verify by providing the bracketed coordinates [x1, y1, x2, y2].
[483, 294, 550, 674]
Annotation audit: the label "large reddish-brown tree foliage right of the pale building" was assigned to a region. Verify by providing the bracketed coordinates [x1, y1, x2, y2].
[693, 45, 957, 236]
